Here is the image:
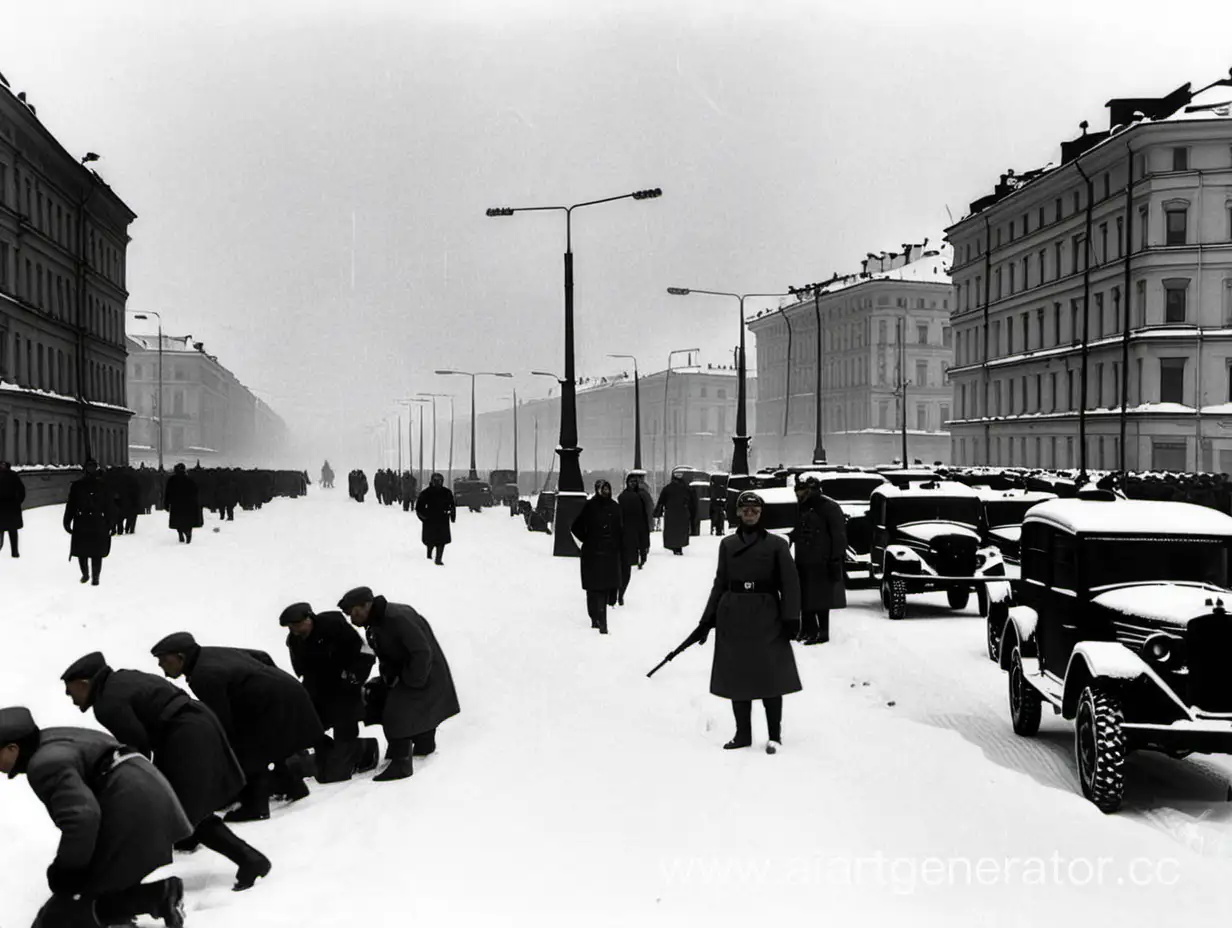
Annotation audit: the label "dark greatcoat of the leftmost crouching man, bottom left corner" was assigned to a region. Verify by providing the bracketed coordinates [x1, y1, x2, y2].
[26, 728, 192, 895]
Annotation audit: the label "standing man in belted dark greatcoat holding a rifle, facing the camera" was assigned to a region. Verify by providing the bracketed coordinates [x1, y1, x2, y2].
[699, 490, 801, 754]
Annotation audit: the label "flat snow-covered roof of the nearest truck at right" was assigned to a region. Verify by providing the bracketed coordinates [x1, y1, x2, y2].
[1024, 499, 1232, 537]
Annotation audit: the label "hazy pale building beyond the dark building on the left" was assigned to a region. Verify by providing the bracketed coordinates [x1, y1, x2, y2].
[127, 335, 286, 467]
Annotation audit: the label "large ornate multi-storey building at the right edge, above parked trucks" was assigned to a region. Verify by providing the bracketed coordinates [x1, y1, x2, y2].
[946, 79, 1232, 472]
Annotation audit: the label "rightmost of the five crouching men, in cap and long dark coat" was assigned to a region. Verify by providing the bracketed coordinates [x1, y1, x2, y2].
[338, 586, 461, 780]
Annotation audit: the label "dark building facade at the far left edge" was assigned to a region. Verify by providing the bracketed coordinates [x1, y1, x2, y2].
[0, 81, 137, 467]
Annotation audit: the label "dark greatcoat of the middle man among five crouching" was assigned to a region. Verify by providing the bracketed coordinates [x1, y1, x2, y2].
[184, 646, 325, 778]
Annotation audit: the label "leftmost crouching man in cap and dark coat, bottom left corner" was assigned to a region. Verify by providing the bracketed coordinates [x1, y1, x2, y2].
[0, 706, 192, 928]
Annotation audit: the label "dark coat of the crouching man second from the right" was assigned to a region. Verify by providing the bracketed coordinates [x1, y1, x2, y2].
[287, 611, 376, 728]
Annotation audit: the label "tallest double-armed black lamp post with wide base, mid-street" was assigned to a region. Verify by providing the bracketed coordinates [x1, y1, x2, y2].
[488, 187, 663, 557]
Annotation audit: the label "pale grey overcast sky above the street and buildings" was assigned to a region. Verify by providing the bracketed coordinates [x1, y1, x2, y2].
[9, 0, 1232, 466]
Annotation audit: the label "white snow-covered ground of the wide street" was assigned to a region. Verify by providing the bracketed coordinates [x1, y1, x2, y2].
[0, 485, 1232, 928]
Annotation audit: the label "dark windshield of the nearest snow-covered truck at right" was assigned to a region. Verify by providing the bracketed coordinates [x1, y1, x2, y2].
[1084, 536, 1228, 589]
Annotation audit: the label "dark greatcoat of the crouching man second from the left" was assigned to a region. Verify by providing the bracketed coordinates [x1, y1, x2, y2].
[90, 667, 244, 826]
